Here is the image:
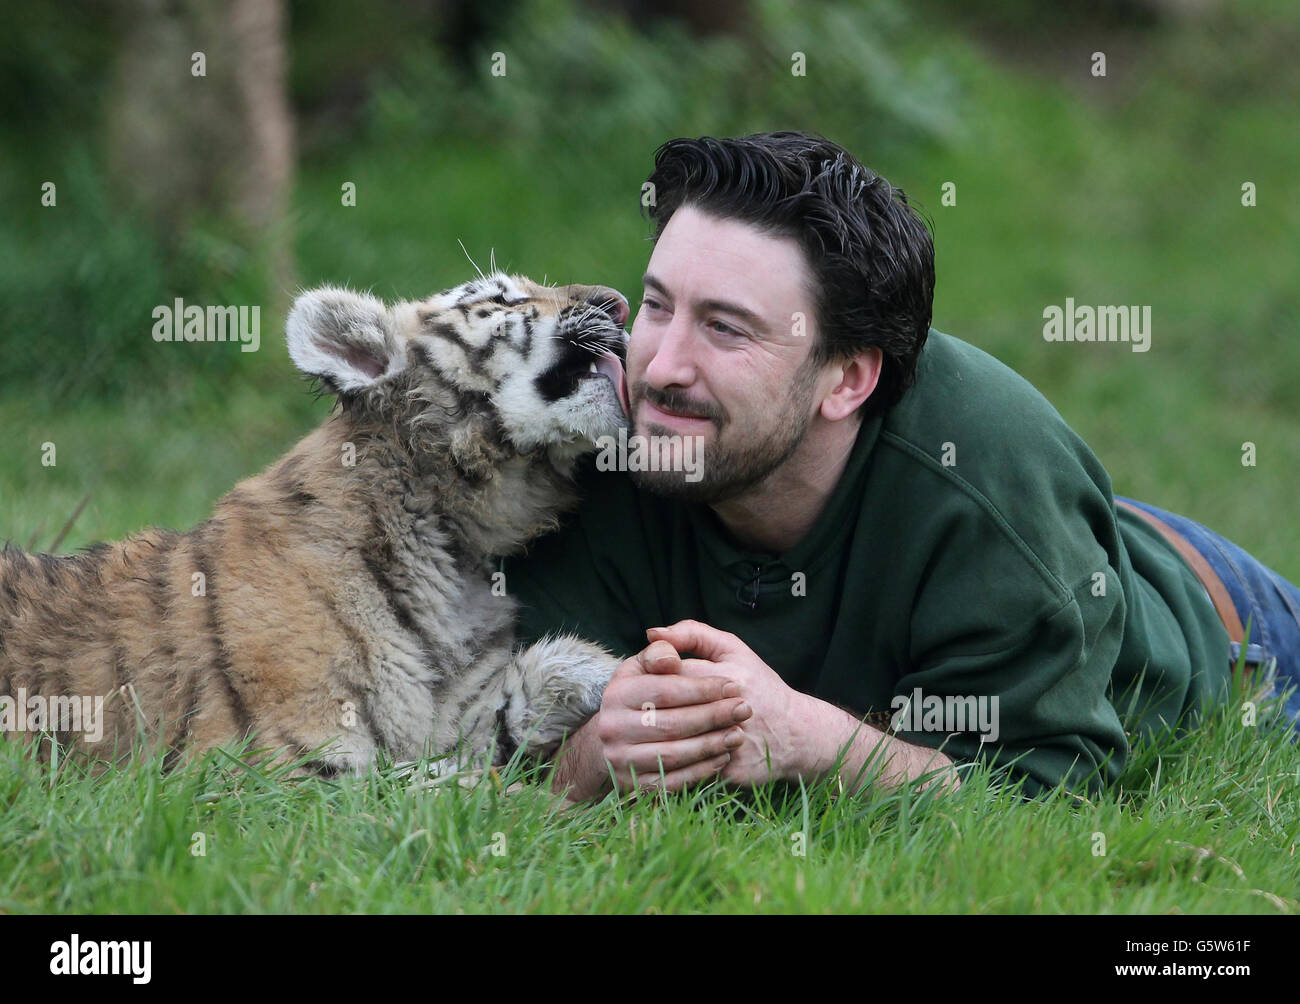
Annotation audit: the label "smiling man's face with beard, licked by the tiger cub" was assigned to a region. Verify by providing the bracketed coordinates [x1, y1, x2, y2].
[627, 205, 823, 503]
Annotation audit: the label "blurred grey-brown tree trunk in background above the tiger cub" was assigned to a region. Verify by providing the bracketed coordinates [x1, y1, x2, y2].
[108, 0, 294, 293]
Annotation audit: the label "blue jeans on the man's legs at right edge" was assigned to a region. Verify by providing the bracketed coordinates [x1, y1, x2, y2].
[1115, 495, 1300, 739]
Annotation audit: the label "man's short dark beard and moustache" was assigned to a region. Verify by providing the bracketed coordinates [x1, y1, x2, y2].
[631, 358, 818, 505]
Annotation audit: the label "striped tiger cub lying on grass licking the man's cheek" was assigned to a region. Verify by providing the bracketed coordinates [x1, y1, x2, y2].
[0, 274, 628, 775]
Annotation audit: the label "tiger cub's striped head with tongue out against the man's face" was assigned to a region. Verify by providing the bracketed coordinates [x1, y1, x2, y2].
[287, 266, 628, 462]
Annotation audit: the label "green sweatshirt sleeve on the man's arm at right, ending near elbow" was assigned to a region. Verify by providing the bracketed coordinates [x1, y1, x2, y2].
[894, 502, 1128, 797]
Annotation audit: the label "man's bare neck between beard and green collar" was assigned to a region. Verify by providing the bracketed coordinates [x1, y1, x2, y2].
[712, 417, 862, 554]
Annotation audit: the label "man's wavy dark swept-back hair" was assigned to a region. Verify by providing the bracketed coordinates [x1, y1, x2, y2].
[647, 133, 935, 416]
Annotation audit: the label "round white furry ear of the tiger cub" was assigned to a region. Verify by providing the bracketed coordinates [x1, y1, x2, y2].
[285, 286, 406, 393]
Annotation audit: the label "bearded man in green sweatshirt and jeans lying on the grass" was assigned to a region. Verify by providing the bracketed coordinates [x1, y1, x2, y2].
[504, 133, 1300, 800]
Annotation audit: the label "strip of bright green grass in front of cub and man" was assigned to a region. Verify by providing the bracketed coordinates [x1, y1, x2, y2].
[0, 671, 1300, 913]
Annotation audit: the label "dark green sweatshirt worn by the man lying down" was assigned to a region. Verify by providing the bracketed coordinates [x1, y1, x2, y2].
[503, 330, 1230, 796]
